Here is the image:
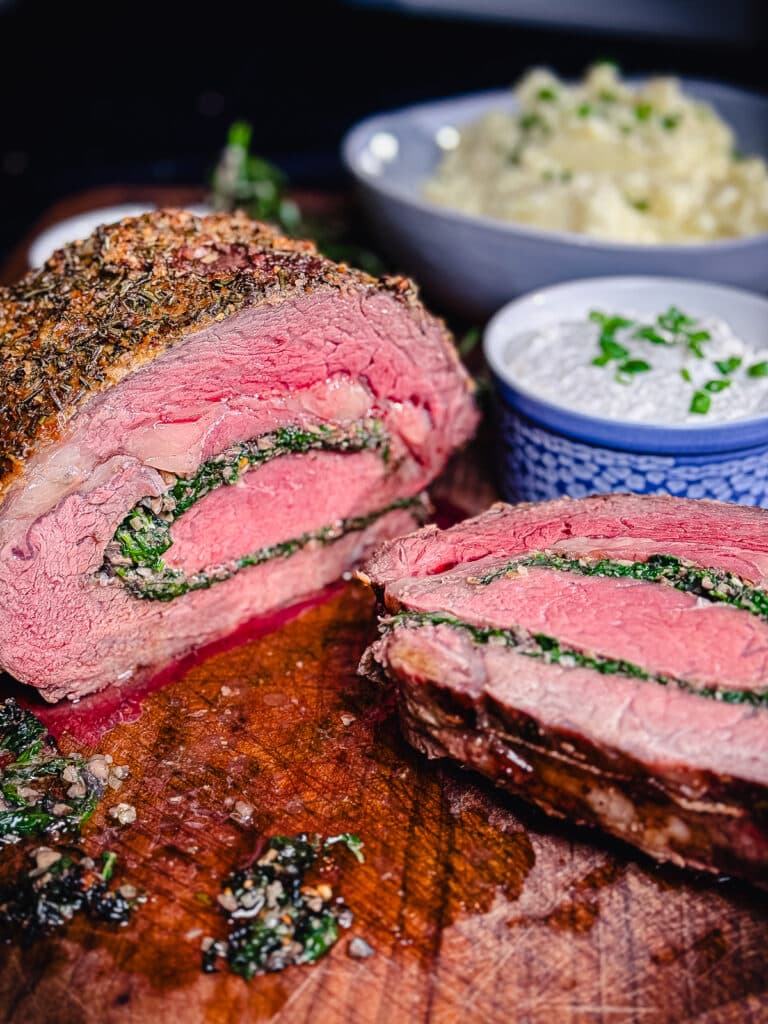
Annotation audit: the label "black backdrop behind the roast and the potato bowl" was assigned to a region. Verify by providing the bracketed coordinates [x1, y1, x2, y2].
[0, 0, 768, 259]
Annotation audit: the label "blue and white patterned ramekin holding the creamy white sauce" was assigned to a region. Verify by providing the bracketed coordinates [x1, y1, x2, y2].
[483, 276, 768, 507]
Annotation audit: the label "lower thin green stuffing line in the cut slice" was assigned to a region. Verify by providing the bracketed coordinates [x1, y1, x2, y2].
[382, 611, 768, 708]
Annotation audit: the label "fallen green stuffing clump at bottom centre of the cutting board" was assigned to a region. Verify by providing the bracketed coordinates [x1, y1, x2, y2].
[202, 833, 364, 979]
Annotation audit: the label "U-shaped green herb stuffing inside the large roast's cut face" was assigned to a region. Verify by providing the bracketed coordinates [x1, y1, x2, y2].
[101, 420, 424, 601]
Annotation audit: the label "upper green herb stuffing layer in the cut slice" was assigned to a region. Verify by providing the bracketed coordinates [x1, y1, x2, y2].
[471, 551, 768, 620]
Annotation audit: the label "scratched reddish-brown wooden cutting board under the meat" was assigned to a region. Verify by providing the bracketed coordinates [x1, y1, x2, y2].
[0, 190, 768, 1024]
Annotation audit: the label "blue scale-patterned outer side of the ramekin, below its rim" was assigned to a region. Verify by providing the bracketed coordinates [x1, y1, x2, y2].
[497, 400, 768, 507]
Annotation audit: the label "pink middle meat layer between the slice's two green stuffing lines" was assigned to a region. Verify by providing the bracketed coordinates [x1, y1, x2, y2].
[387, 563, 768, 690]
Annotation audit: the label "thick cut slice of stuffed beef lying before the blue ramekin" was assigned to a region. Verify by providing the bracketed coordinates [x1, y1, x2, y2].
[361, 495, 768, 884]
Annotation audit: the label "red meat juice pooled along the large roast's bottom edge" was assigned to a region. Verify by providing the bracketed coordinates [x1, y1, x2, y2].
[0, 581, 344, 745]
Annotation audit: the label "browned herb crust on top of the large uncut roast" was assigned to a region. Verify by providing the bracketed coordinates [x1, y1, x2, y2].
[0, 209, 428, 497]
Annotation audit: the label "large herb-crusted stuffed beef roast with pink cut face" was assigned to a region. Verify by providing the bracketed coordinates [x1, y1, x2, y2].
[0, 210, 476, 700]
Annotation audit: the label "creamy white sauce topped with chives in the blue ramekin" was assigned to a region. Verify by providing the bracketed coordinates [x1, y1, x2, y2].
[506, 310, 768, 427]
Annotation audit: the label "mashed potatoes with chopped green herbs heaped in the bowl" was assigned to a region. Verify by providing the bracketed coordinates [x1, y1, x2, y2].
[425, 63, 768, 243]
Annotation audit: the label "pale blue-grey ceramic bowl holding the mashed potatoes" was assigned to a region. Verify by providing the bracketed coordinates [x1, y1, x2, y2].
[342, 79, 768, 317]
